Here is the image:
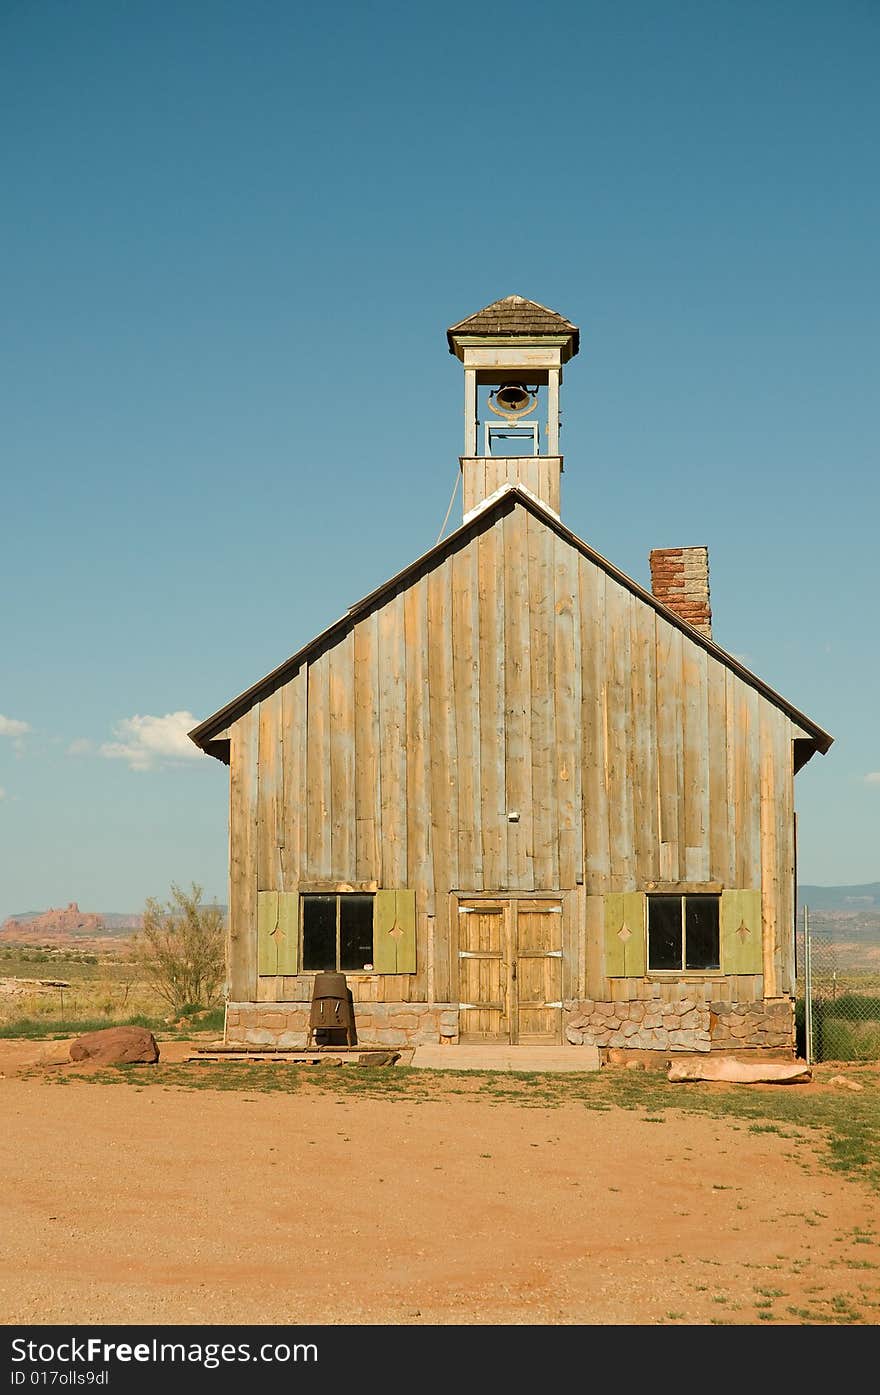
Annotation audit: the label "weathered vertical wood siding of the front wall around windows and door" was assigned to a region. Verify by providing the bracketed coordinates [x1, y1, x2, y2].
[230, 505, 794, 1002]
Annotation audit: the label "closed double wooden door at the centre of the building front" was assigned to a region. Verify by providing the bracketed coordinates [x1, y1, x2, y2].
[457, 897, 562, 1045]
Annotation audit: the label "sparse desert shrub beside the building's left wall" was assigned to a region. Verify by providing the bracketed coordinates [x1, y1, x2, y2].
[134, 883, 226, 1016]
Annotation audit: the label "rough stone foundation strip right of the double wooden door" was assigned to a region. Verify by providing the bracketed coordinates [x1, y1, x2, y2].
[565, 997, 795, 1053]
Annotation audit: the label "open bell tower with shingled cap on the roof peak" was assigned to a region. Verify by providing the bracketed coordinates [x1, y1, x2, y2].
[446, 296, 580, 519]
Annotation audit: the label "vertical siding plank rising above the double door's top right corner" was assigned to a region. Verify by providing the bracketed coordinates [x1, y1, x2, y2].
[551, 534, 584, 881]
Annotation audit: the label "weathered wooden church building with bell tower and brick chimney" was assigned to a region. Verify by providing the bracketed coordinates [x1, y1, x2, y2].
[191, 296, 831, 1053]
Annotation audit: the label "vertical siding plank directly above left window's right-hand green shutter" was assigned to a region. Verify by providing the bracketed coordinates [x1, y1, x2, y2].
[379, 591, 406, 887]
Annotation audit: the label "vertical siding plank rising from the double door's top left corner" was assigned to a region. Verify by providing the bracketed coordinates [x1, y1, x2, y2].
[452, 541, 483, 889]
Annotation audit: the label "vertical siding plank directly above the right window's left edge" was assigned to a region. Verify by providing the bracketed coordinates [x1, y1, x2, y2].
[628, 596, 660, 886]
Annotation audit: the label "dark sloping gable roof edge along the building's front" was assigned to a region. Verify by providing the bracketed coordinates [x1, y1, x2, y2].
[188, 484, 834, 770]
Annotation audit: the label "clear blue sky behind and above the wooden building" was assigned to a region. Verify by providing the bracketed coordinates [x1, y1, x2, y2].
[0, 0, 880, 915]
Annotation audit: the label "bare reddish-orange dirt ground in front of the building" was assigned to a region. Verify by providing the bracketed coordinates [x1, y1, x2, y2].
[0, 1042, 880, 1325]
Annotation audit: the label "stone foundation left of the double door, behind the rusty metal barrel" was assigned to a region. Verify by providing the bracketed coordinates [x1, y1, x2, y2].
[226, 1003, 459, 1050]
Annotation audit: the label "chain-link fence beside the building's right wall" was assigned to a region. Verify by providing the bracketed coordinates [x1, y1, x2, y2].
[796, 907, 880, 1062]
